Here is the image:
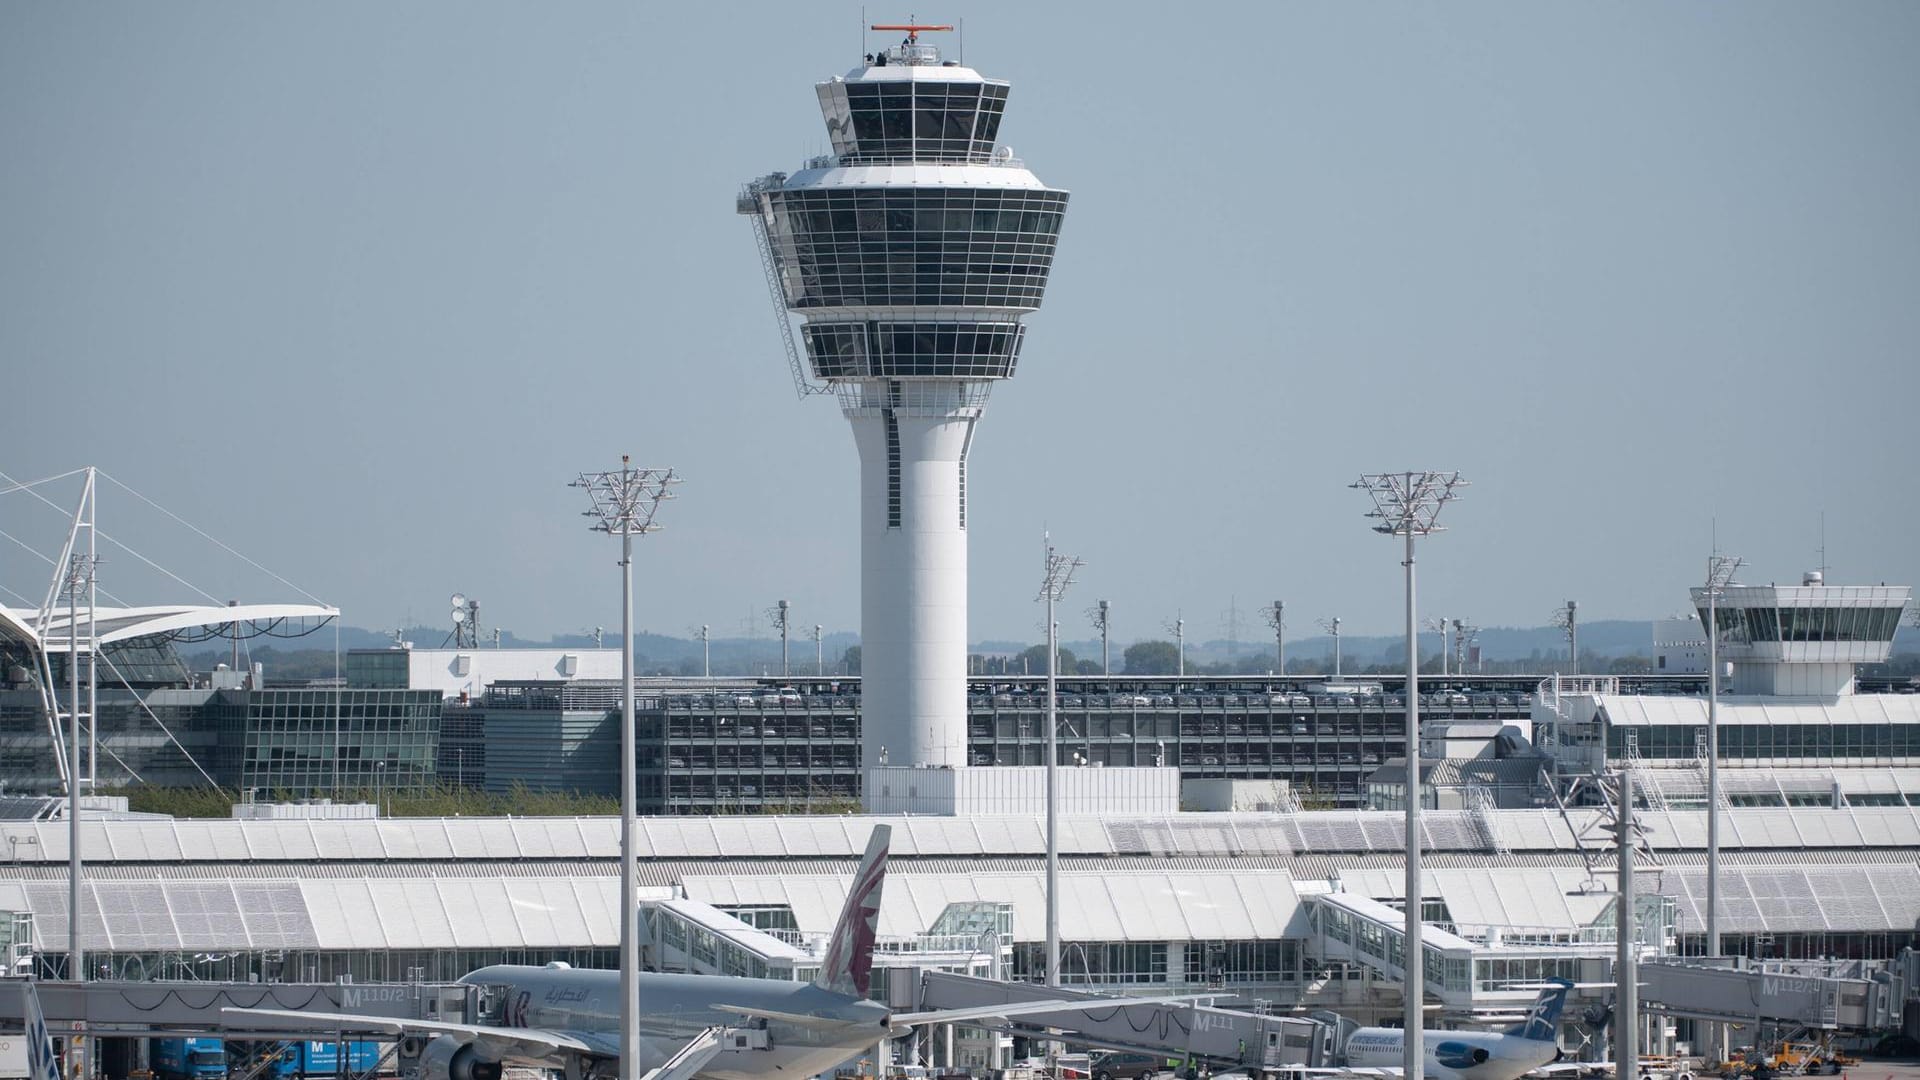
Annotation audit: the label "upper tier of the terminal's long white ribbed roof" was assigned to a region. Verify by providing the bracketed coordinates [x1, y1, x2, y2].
[0, 807, 1920, 863]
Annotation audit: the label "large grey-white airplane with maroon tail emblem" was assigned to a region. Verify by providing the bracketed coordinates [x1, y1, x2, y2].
[221, 824, 1192, 1080]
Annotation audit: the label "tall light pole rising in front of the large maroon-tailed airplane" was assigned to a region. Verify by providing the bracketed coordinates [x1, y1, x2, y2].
[568, 454, 680, 1076]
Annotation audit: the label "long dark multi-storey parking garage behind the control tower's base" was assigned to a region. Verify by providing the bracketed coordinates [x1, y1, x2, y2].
[440, 676, 1536, 813]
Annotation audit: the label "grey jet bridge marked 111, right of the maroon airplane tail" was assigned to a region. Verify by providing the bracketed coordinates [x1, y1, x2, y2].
[920, 960, 1334, 1074]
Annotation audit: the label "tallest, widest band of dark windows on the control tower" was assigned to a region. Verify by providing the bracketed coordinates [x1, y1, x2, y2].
[770, 188, 1068, 309]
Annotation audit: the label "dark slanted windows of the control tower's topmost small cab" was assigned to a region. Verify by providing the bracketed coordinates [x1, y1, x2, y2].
[818, 79, 1006, 163]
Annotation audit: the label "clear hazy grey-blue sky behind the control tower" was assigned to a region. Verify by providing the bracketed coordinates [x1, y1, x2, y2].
[0, 2, 1920, 640]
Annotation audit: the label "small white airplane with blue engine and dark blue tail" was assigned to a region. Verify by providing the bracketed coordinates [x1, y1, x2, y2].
[1308, 980, 1578, 1080]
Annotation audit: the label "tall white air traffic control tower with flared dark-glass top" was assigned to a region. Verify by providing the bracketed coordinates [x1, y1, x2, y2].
[737, 27, 1068, 767]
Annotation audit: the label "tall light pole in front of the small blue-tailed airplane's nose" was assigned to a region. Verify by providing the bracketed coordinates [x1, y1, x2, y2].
[1354, 463, 1467, 1080]
